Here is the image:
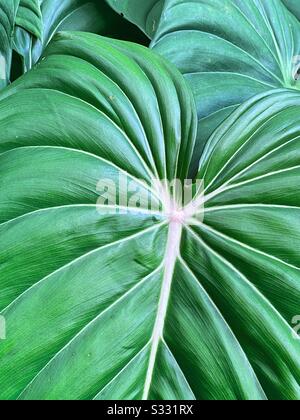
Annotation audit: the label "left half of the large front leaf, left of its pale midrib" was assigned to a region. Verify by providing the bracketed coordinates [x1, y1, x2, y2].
[0, 34, 196, 399]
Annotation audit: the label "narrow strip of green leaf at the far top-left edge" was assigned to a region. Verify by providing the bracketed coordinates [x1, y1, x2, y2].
[0, 0, 19, 90]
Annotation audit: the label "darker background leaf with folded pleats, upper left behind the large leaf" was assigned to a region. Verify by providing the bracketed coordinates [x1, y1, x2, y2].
[11, 0, 146, 80]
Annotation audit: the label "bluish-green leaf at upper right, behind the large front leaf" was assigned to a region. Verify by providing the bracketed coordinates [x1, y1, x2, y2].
[116, 0, 300, 175]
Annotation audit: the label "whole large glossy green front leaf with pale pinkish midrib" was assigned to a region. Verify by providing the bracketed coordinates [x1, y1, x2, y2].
[0, 33, 300, 400]
